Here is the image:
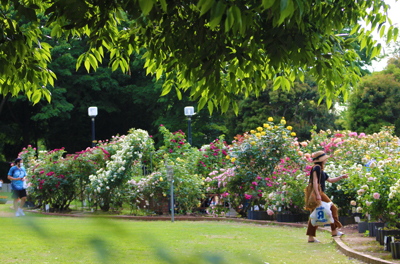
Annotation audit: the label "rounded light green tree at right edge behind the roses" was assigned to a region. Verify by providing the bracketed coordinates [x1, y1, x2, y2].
[345, 57, 400, 135]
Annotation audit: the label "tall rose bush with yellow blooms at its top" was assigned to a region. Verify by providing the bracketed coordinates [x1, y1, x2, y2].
[206, 117, 299, 215]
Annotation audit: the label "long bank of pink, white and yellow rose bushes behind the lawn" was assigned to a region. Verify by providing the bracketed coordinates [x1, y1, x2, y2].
[2, 117, 400, 262]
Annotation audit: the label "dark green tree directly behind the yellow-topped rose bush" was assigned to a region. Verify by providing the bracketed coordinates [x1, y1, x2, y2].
[227, 76, 336, 140]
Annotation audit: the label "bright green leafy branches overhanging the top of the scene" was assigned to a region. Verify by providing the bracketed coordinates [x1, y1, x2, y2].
[0, 0, 398, 112]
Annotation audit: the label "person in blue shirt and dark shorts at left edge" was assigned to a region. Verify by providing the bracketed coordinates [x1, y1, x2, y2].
[8, 158, 26, 217]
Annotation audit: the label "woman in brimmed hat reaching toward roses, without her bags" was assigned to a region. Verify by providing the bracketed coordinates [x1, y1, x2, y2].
[307, 151, 349, 243]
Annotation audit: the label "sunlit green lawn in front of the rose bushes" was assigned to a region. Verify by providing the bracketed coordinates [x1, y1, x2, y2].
[0, 205, 353, 264]
